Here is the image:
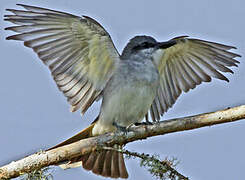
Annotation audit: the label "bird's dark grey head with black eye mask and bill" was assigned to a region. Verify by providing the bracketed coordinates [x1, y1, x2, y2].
[121, 36, 175, 59]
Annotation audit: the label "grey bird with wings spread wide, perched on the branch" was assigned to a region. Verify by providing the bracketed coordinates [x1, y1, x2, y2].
[4, 4, 241, 178]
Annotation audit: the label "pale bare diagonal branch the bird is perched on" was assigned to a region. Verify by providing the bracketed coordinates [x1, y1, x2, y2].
[0, 105, 245, 179]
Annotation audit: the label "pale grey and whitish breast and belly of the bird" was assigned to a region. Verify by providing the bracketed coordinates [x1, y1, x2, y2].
[94, 59, 159, 134]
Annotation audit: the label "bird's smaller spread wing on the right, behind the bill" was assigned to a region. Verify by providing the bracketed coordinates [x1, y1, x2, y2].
[150, 37, 241, 121]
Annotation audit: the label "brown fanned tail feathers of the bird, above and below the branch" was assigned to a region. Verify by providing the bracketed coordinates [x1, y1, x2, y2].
[48, 123, 128, 178]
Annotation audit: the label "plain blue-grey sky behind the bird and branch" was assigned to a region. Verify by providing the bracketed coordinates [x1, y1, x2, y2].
[0, 0, 245, 180]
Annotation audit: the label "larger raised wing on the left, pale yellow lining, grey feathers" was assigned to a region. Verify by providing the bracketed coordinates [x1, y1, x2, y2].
[5, 4, 119, 113]
